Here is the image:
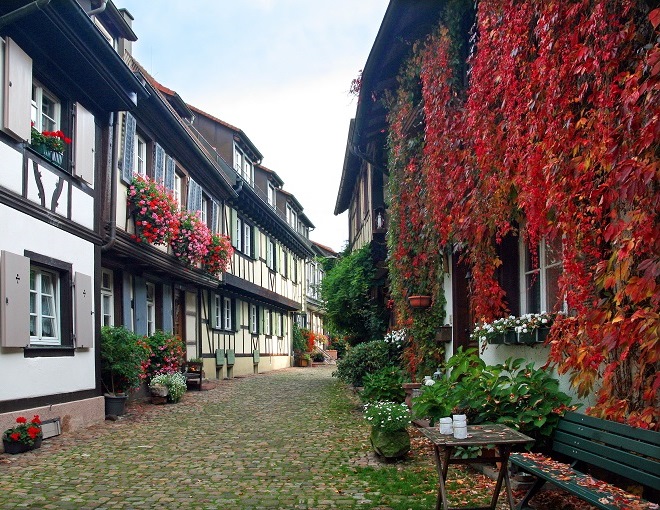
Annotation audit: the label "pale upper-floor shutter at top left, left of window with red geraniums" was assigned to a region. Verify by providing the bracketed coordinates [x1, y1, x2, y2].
[3, 37, 32, 141]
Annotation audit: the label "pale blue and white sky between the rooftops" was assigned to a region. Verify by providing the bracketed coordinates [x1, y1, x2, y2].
[114, 0, 388, 251]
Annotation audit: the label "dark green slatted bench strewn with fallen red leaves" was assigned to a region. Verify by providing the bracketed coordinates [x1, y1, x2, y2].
[509, 413, 660, 510]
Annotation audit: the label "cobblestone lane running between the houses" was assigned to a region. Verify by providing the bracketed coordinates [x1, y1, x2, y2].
[0, 366, 386, 510]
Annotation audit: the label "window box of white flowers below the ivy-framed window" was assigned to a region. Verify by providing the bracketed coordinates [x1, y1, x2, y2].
[471, 312, 555, 345]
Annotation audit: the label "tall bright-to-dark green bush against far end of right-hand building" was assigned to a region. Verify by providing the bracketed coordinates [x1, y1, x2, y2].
[321, 245, 387, 345]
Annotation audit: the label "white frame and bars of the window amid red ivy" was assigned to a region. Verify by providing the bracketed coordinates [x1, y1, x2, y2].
[520, 239, 567, 314]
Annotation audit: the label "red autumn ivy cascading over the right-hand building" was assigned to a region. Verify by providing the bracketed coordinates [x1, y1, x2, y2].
[390, 0, 660, 428]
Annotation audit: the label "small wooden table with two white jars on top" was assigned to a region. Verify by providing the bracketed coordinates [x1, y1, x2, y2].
[419, 425, 534, 510]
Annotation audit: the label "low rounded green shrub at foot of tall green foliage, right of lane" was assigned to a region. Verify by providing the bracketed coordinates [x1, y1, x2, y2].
[332, 340, 394, 387]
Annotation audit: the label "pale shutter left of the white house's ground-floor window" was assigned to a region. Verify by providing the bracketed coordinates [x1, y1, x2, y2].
[0, 250, 30, 347]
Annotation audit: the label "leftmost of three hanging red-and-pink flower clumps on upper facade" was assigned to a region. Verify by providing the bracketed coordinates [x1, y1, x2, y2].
[127, 175, 180, 245]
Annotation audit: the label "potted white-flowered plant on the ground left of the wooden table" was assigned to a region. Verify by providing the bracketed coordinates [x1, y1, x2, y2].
[364, 401, 410, 459]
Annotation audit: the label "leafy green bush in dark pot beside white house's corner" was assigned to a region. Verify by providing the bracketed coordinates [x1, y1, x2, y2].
[100, 326, 149, 416]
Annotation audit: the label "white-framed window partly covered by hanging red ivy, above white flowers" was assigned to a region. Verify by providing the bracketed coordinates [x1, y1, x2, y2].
[521, 238, 563, 313]
